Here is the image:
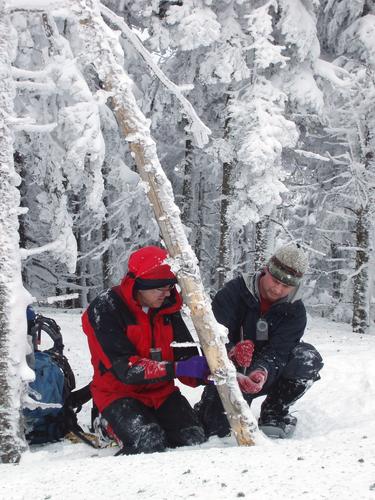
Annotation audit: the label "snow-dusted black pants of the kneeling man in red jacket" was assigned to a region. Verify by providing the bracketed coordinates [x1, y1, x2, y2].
[103, 391, 206, 454]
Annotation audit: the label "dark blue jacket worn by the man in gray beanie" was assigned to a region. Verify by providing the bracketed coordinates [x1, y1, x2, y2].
[212, 274, 306, 382]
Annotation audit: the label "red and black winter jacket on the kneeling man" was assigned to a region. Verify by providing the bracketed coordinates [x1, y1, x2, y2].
[82, 247, 199, 412]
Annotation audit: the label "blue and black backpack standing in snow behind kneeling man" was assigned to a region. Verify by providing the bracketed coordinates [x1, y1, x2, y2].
[23, 308, 91, 444]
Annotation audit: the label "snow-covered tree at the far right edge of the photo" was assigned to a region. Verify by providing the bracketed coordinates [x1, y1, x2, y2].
[321, 1, 375, 333]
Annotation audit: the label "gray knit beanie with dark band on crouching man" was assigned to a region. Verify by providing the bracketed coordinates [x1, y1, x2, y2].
[267, 243, 309, 286]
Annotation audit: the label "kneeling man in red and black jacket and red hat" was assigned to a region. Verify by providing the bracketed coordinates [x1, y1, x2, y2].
[82, 246, 209, 454]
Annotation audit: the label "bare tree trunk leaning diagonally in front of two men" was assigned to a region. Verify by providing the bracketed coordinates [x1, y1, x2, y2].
[72, 0, 262, 445]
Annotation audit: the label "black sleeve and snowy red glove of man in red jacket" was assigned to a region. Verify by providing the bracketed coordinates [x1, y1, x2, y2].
[88, 290, 174, 384]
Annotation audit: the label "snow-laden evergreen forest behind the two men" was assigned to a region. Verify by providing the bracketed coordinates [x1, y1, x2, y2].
[0, 0, 375, 464]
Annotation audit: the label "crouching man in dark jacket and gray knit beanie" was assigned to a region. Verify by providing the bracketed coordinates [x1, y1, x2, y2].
[196, 244, 323, 438]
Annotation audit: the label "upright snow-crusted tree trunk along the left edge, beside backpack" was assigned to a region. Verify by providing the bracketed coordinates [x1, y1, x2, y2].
[0, 0, 26, 463]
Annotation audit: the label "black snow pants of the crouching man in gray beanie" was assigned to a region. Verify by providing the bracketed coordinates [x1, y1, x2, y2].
[195, 342, 323, 437]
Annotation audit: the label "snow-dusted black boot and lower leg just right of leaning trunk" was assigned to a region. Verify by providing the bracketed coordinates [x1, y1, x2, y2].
[258, 378, 312, 438]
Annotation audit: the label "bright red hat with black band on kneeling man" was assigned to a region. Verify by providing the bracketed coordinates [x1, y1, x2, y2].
[128, 246, 177, 290]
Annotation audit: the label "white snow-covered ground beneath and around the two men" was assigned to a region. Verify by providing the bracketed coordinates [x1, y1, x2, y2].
[0, 311, 375, 500]
